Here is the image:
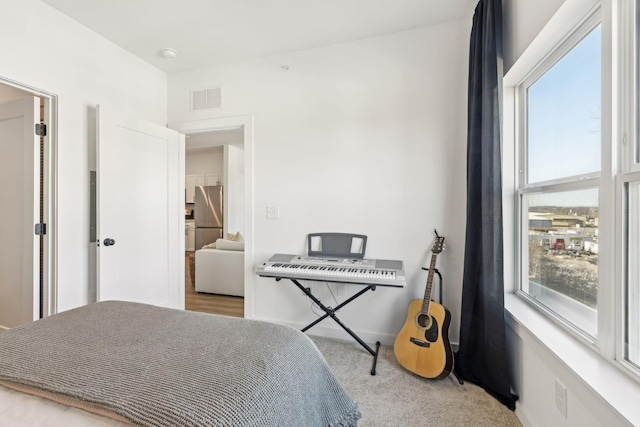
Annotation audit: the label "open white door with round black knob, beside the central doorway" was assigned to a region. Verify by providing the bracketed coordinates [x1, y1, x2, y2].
[96, 106, 184, 309]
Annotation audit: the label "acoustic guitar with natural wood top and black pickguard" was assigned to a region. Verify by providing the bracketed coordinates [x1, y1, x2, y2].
[393, 230, 453, 379]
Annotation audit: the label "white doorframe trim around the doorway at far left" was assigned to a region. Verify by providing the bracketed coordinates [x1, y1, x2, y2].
[0, 77, 58, 318]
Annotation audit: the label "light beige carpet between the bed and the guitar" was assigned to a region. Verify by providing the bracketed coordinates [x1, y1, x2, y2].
[310, 336, 522, 427]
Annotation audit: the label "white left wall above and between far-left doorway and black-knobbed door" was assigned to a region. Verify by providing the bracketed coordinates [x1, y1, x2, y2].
[0, 0, 167, 311]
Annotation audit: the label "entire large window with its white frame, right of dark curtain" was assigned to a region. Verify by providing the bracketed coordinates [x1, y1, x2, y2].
[509, 0, 640, 378]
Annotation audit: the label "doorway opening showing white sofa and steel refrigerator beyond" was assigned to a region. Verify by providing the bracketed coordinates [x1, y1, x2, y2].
[185, 127, 245, 317]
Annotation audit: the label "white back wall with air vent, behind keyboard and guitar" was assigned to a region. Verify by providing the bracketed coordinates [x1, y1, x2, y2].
[168, 19, 471, 343]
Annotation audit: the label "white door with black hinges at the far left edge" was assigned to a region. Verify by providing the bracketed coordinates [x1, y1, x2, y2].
[0, 97, 40, 328]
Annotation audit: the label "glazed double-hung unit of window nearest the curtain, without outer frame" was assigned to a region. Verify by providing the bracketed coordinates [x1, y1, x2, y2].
[518, 18, 602, 339]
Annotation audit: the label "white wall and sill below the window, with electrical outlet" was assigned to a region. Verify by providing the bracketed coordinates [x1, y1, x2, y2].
[506, 295, 640, 427]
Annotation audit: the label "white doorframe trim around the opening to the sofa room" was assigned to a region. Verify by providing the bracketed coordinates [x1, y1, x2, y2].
[167, 115, 255, 319]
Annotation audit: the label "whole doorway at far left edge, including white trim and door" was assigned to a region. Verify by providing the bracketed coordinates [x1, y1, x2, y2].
[0, 78, 56, 328]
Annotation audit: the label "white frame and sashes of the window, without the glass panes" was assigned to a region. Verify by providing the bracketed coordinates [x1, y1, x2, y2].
[510, 0, 640, 382]
